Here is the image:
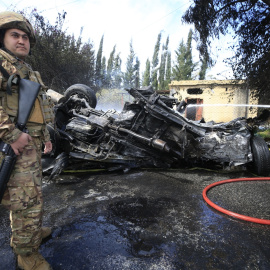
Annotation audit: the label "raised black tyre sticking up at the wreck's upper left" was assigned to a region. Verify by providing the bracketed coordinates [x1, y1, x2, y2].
[64, 84, 97, 108]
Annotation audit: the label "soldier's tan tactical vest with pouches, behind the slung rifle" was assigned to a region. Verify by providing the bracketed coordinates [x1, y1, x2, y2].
[0, 49, 54, 126]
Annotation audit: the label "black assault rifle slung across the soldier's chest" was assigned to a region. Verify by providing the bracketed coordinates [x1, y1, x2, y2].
[0, 75, 41, 203]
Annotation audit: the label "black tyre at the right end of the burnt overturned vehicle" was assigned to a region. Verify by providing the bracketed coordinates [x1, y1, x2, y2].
[251, 136, 270, 176]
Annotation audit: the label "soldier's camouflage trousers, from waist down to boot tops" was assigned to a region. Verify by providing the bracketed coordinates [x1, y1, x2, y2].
[0, 137, 43, 255]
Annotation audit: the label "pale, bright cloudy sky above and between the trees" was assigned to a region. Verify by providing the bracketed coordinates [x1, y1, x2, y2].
[0, 0, 235, 79]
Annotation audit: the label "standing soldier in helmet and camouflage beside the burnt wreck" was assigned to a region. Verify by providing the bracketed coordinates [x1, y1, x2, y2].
[0, 11, 53, 270]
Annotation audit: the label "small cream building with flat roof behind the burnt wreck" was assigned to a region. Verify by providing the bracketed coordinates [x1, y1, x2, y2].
[169, 80, 258, 122]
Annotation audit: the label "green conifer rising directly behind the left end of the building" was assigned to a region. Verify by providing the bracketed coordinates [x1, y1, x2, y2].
[172, 30, 196, 80]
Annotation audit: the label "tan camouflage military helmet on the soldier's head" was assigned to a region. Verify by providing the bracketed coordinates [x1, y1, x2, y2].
[0, 11, 36, 48]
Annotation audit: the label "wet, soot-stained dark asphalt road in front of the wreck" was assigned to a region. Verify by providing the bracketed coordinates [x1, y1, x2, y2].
[0, 169, 270, 270]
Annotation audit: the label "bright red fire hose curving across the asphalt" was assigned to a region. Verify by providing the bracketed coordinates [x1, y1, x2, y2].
[202, 177, 270, 225]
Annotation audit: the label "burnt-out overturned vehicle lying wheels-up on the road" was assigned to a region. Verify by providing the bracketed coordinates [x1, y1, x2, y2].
[44, 85, 270, 178]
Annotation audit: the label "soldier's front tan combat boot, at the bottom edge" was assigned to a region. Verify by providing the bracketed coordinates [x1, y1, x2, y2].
[18, 252, 52, 270]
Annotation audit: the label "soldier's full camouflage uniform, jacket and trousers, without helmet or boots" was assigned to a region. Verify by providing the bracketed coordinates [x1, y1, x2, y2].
[0, 49, 53, 255]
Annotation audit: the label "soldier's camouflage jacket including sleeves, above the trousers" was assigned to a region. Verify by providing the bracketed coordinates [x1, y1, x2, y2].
[0, 49, 54, 144]
